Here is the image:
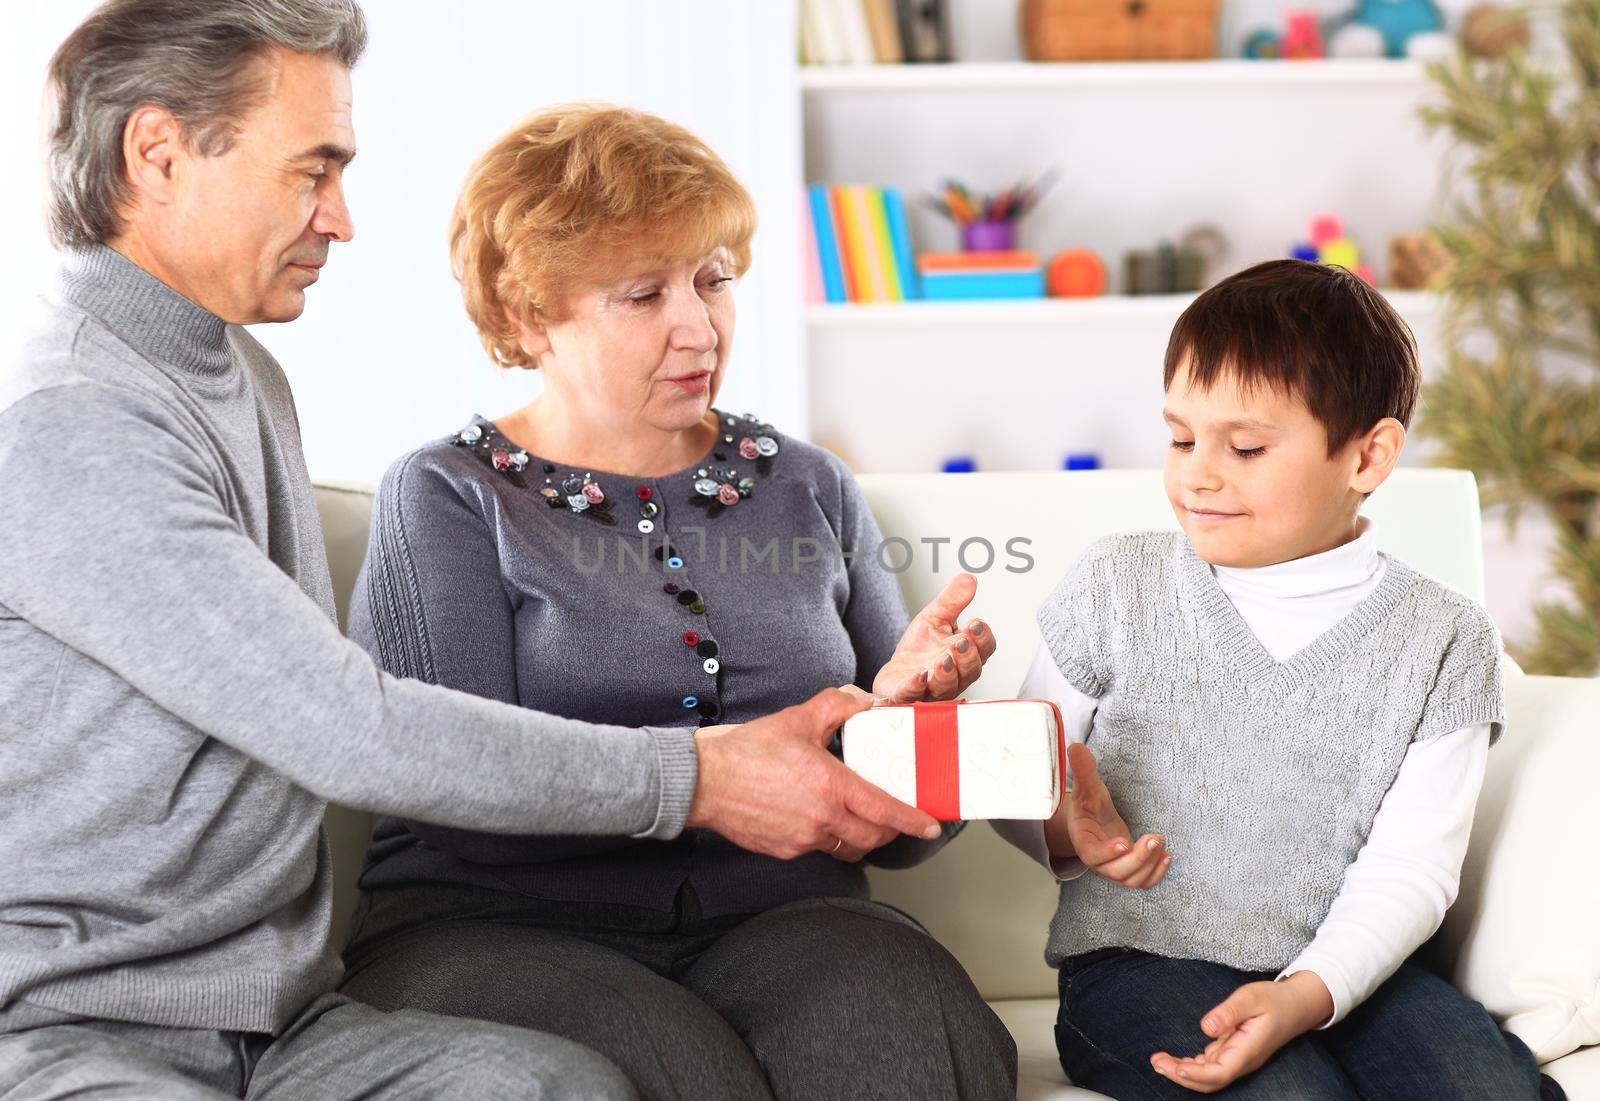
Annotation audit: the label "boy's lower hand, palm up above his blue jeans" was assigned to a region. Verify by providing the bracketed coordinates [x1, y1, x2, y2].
[1150, 971, 1333, 1093]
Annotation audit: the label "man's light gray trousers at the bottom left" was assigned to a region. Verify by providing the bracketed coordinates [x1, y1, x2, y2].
[0, 994, 635, 1101]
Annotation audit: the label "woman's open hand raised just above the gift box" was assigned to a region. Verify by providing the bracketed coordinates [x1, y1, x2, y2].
[872, 573, 995, 704]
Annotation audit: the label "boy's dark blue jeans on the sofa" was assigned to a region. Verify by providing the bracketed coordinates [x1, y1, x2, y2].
[1056, 947, 1563, 1101]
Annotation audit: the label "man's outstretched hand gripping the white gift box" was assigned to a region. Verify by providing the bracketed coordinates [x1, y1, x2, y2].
[686, 688, 939, 861]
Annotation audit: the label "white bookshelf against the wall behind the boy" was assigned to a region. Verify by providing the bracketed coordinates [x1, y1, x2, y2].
[798, 25, 1443, 472]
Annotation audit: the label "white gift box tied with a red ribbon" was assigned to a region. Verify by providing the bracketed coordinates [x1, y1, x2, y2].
[843, 699, 1067, 823]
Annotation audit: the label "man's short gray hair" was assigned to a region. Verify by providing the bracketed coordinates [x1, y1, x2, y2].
[48, 0, 366, 248]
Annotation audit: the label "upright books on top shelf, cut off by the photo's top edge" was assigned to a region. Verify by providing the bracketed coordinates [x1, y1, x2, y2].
[800, 0, 950, 66]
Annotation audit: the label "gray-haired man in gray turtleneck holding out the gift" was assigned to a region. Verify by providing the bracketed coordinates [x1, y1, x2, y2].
[0, 0, 938, 1098]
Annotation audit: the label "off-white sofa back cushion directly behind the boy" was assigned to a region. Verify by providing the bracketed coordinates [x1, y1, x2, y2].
[859, 469, 1483, 999]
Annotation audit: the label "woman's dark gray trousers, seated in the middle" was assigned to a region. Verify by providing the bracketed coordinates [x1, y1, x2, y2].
[344, 885, 1016, 1101]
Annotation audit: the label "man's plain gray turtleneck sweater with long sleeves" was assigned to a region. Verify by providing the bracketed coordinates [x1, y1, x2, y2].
[0, 248, 694, 1032]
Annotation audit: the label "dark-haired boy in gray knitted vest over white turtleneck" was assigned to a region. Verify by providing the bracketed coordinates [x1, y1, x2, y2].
[1002, 261, 1539, 1101]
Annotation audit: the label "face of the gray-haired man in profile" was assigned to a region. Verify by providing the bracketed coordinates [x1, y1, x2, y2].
[168, 50, 355, 325]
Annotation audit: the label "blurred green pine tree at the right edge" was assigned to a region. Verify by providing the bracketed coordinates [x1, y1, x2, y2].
[1421, 0, 1600, 675]
